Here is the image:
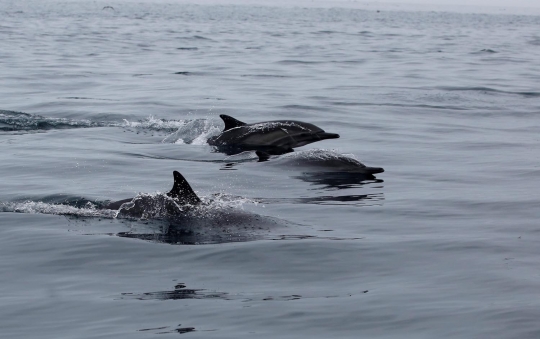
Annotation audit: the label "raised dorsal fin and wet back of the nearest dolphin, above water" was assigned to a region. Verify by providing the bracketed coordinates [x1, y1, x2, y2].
[102, 171, 201, 218]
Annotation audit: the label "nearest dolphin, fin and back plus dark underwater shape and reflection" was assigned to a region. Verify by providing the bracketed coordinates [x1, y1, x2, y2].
[99, 171, 287, 244]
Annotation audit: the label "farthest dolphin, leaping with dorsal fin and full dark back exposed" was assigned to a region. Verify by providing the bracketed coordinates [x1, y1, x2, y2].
[208, 114, 339, 154]
